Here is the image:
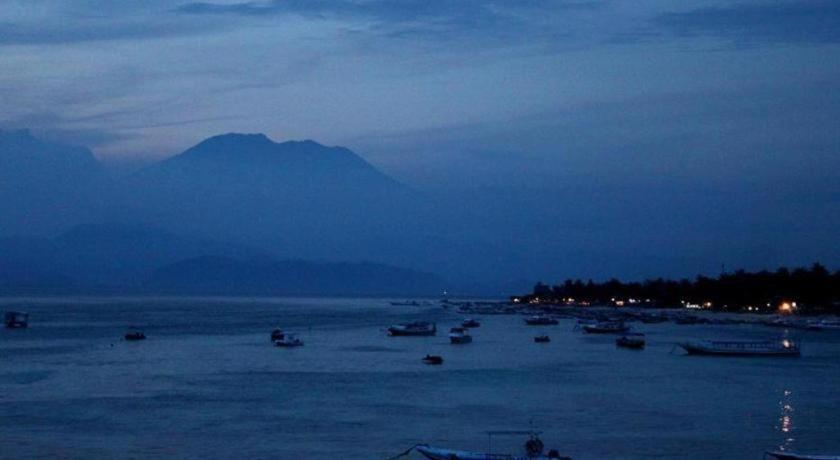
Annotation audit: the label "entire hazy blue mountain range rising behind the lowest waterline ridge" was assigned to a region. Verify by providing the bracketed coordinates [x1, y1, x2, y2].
[0, 131, 498, 292]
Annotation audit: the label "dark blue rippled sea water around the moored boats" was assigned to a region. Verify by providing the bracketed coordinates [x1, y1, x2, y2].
[0, 298, 840, 459]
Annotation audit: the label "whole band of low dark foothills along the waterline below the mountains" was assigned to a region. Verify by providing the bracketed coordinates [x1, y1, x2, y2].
[0, 224, 444, 295]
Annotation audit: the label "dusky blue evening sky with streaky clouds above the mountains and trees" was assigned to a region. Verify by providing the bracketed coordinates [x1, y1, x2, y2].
[0, 0, 840, 280]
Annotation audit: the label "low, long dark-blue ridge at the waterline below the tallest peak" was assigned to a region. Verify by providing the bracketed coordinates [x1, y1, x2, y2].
[145, 253, 445, 296]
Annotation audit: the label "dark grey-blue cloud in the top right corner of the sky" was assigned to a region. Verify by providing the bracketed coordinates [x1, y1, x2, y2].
[652, 0, 840, 46]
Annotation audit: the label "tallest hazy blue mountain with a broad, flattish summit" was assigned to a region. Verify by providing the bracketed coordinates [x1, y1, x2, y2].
[109, 134, 430, 265]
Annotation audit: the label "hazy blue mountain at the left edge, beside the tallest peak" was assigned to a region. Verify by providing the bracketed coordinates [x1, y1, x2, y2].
[0, 130, 104, 235]
